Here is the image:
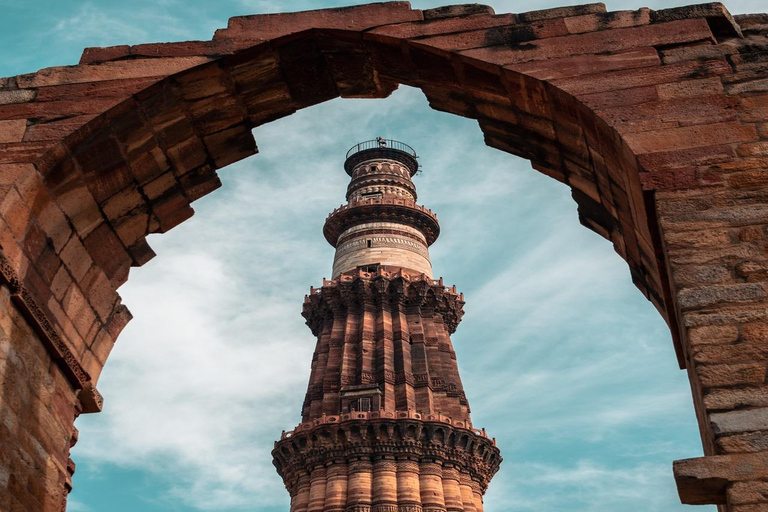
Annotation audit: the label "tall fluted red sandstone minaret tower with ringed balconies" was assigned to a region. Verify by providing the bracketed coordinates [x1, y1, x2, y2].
[272, 138, 501, 512]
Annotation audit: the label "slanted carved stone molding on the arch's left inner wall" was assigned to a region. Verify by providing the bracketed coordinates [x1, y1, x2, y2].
[0, 252, 92, 396]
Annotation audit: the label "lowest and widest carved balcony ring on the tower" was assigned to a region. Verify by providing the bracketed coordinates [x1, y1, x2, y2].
[272, 418, 501, 492]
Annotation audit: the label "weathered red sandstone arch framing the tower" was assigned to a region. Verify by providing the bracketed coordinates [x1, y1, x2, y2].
[0, 2, 768, 512]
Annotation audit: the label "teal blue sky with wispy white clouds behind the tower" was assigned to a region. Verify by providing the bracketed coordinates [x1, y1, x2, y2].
[0, 0, 764, 512]
